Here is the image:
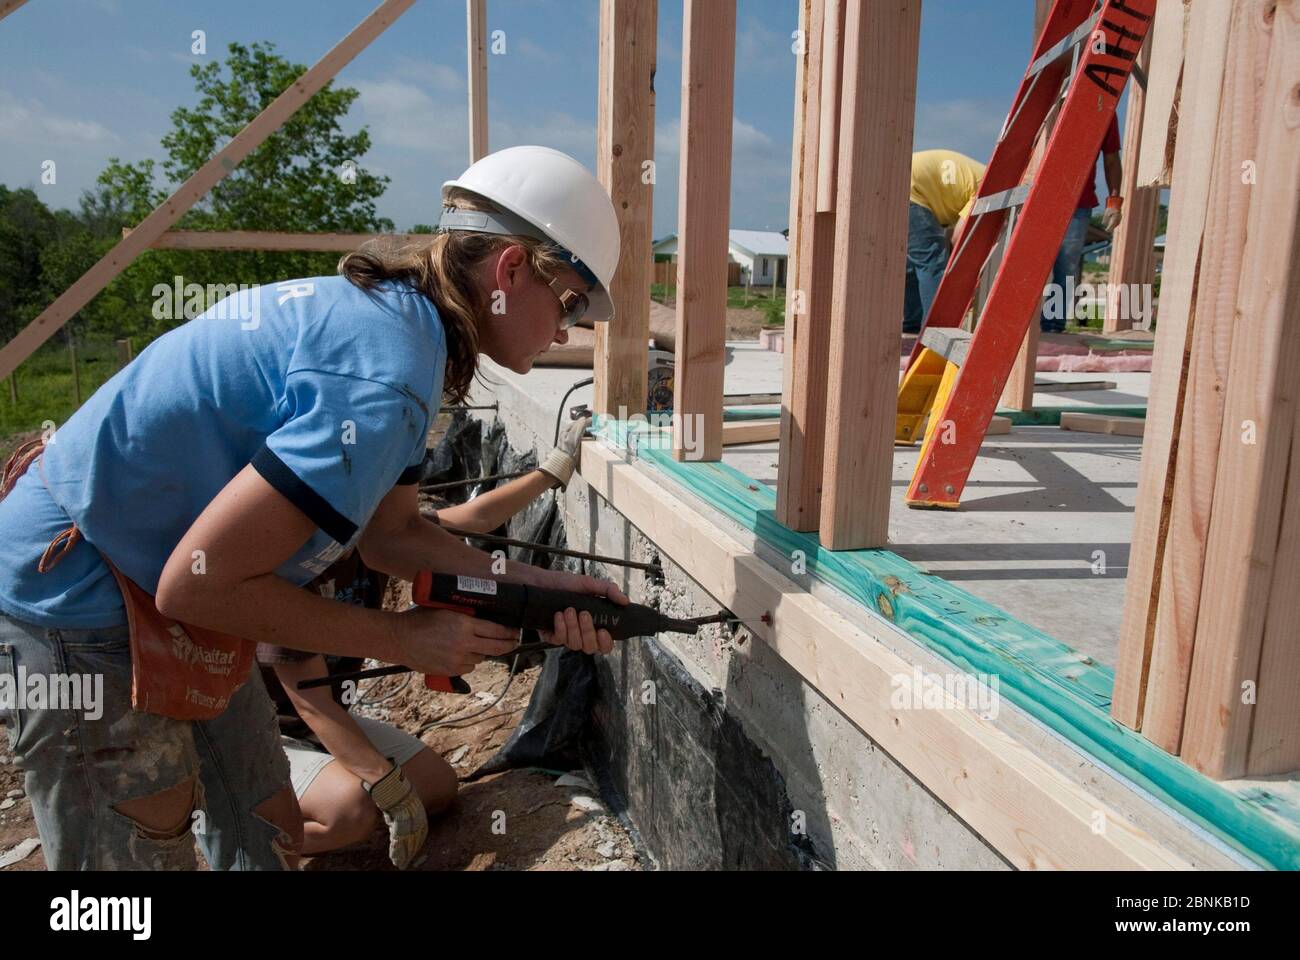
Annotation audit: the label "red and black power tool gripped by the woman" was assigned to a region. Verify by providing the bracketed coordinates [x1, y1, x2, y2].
[298, 570, 735, 693]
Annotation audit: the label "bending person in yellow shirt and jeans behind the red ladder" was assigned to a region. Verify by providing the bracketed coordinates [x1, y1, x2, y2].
[902, 150, 984, 333]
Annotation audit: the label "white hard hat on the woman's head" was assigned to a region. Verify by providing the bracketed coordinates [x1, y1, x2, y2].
[439, 147, 619, 320]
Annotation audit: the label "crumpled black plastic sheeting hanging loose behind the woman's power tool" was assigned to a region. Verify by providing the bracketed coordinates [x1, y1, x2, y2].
[421, 414, 595, 780]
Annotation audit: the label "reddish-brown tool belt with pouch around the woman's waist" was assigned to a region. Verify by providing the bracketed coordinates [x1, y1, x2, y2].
[0, 440, 257, 721]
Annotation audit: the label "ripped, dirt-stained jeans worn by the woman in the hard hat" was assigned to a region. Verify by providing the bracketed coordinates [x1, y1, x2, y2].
[0, 614, 290, 870]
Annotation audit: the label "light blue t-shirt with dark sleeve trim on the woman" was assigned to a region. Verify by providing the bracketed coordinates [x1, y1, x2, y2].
[0, 277, 447, 628]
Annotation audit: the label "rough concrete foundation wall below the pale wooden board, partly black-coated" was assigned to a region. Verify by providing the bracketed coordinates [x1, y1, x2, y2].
[475, 366, 1006, 869]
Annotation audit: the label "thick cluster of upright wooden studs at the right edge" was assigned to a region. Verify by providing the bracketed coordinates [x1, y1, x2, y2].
[1113, 0, 1300, 779]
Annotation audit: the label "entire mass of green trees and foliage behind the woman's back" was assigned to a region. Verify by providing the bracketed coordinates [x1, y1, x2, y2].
[0, 43, 393, 437]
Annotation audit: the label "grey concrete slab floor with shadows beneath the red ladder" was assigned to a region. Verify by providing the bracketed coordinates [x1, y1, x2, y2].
[504, 341, 1151, 666]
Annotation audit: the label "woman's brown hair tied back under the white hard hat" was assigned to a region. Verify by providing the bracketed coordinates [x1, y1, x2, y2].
[338, 190, 563, 403]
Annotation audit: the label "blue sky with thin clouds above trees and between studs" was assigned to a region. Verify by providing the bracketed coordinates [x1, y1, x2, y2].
[0, 0, 1118, 237]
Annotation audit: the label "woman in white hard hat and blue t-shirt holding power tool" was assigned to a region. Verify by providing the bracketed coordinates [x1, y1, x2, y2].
[0, 147, 627, 869]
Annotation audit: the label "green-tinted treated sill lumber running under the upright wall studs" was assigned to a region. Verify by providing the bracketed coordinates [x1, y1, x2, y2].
[595, 416, 1300, 869]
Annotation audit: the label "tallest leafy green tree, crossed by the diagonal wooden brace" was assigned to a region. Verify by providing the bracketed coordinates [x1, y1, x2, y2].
[89, 43, 393, 347]
